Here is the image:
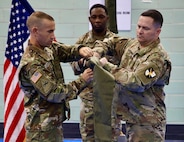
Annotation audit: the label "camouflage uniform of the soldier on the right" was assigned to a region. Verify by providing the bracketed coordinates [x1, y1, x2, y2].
[96, 37, 171, 142]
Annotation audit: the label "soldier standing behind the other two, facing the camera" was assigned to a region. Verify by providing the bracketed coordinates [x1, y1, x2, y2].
[71, 4, 123, 142]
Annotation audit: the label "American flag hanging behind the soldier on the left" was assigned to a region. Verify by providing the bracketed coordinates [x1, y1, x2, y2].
[3, 0, 34, 142]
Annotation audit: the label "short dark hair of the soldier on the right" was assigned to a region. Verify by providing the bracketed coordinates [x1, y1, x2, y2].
[141, 9, 163, 28]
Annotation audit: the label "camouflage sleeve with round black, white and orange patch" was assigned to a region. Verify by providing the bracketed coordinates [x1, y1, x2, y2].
[113, 53, 167, 92]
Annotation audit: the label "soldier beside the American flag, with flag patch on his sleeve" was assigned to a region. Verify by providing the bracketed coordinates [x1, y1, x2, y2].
[19, 11, 93, 142]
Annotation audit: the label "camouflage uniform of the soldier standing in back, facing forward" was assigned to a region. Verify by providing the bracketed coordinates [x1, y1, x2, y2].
[71, 30, 118, 142]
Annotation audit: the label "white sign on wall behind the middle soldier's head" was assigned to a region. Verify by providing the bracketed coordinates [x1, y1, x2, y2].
[89, 0, 131, 31]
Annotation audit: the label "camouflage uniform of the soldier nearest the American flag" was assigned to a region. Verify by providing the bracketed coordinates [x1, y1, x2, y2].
[19, 42, 86, 142]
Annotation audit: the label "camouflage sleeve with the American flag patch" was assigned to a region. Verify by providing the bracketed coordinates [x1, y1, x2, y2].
[21, 63, 86, 103]
